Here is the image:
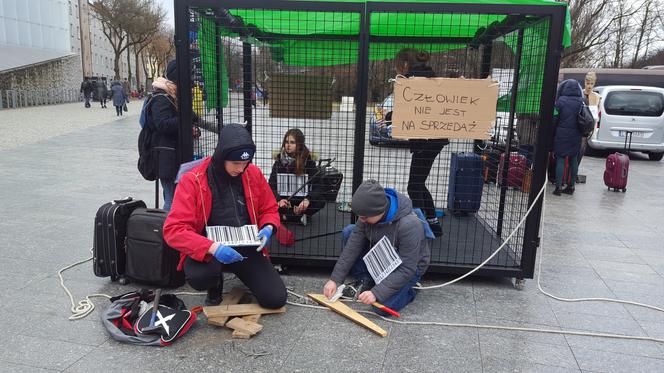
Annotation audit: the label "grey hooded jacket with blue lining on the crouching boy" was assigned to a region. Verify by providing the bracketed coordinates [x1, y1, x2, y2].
[330, 188, 431, 302]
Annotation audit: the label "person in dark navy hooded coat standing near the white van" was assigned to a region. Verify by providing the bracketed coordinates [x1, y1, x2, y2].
[553, 79, 583, 196]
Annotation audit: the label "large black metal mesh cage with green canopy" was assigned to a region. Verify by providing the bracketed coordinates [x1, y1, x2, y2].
[175, 0, 565, 278]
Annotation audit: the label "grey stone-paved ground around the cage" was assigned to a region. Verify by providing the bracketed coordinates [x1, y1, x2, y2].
[0, 103, 664, 372]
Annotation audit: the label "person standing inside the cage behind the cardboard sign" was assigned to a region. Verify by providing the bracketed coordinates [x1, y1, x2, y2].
[395, 48, 450, 237]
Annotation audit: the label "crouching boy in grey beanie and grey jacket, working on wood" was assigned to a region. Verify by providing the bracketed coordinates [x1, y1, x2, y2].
[323, 180, 434, 316]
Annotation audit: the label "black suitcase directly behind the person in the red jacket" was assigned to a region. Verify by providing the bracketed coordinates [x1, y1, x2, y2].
[126, 208, 184, 287]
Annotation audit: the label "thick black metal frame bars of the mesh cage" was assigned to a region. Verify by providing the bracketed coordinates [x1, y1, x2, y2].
[175, 0, 565, 279]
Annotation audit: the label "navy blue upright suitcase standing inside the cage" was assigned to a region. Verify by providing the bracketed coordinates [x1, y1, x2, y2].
[447, 153, 484, 216]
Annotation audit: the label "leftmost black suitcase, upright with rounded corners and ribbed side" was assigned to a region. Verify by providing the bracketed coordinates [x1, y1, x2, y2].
[92, 197, 145, 281]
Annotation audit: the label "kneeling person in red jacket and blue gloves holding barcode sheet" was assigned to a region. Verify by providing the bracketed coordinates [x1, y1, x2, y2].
[164, 124, 286, 308]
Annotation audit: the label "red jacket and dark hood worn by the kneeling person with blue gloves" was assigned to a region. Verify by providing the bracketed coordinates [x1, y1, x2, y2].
[164, 126, 280, 270]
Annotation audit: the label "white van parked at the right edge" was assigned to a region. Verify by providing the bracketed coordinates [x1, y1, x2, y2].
[588, 85, 664, 161]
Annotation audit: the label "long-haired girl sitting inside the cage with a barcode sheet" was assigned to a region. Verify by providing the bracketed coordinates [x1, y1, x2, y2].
[269, 128, 324, 225]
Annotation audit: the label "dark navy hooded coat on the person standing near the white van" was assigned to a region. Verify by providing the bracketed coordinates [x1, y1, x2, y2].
[553, 79, 583, 157]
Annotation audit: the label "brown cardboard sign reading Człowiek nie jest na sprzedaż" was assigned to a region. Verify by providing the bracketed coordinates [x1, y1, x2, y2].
[392, 77, 499, 140]
